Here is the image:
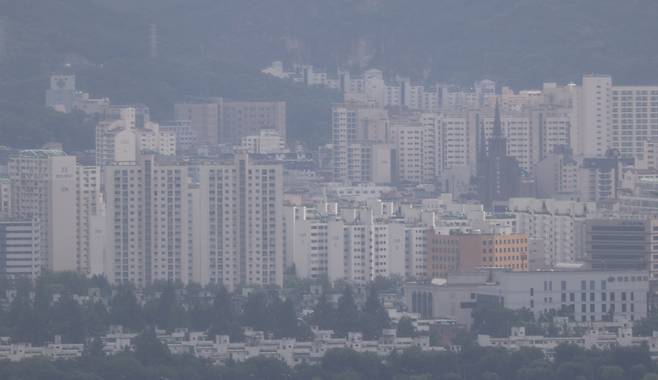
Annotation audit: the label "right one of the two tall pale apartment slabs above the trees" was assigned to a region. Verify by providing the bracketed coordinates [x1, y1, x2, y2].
[198, 154, 284, 289]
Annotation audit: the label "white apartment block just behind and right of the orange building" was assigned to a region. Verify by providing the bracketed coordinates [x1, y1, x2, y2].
[509, 198, 598, 269]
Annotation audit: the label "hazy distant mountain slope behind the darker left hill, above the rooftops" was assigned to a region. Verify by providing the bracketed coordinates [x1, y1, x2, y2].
[92, 0, 658, 87]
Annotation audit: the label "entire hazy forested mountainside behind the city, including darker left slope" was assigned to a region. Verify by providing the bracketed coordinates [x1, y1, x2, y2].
[0, 0, 658, 149]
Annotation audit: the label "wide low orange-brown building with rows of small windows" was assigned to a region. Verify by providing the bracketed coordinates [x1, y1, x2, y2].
[426, 230, 528, 279]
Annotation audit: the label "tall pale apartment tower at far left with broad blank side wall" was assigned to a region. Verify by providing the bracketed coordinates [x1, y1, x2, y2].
[9, 150, 78, 271]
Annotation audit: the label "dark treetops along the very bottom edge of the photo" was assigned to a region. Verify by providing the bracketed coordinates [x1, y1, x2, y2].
[0, 342, 658, 380]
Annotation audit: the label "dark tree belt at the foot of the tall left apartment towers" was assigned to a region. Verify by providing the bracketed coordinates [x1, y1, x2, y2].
[0, 273, 394, 344]
